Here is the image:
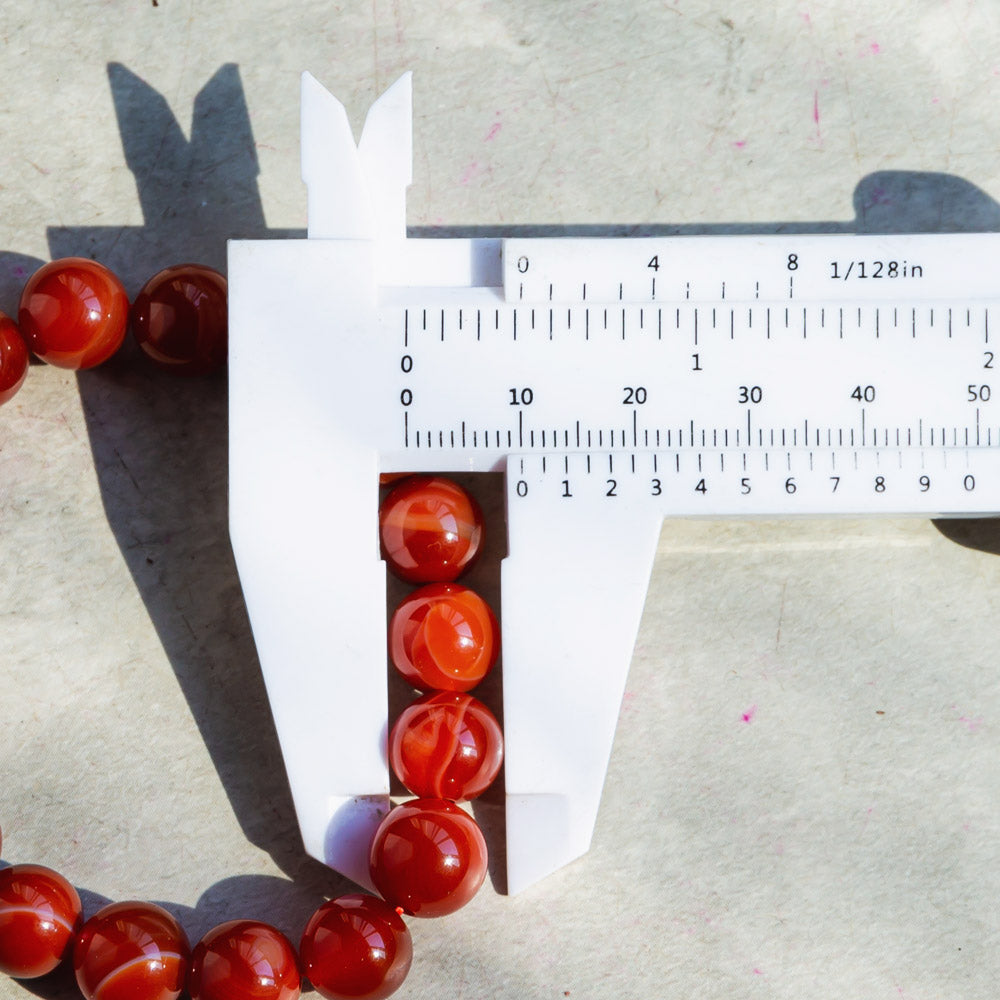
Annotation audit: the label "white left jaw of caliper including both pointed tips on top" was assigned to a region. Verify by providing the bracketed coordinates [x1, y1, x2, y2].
[229, 74, 410, 887]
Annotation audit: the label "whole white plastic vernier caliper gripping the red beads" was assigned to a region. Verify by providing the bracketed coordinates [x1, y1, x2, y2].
[229, 74, 1000, 892]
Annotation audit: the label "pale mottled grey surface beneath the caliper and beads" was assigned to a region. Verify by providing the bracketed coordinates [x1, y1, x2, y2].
[0, 0, 1000, 1000]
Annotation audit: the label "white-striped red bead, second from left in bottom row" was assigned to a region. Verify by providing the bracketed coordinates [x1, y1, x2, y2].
[73, 903, 191, 1000]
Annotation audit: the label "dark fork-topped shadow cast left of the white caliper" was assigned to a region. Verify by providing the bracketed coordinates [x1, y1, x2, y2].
[51, 63, 351, 935]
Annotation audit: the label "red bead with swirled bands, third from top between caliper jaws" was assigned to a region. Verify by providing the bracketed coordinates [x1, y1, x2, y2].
[389, 691, 503, 799]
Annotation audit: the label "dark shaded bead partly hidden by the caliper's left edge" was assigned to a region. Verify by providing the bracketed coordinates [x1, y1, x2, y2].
[132, 264, 228, 375]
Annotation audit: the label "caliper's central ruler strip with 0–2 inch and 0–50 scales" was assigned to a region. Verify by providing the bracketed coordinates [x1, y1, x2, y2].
[383, 292, 1000, 488]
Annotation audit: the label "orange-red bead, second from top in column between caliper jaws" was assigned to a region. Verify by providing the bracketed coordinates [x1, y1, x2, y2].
[389, 583, 500, 691]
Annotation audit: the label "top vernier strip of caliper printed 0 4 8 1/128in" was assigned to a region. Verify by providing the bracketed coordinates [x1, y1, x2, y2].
[503, 233, 995, 303]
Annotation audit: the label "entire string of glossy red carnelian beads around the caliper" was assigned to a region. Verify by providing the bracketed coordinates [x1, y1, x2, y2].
[0, 257, 503, 1000]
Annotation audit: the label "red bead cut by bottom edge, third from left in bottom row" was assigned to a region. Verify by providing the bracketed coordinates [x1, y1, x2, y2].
[187, 920, 302, 1000]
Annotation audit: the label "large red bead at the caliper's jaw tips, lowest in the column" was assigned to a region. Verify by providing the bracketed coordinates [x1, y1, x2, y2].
[369, 799, 486, 917]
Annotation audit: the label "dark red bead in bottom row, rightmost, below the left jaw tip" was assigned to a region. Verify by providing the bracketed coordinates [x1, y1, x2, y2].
[299, 893, 413, 1000]
